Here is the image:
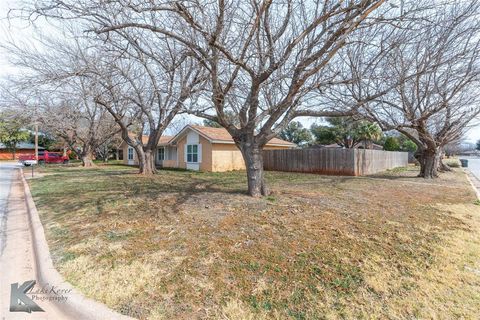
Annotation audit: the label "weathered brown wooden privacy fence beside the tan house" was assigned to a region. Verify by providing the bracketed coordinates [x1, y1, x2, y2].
[263, 148, 408, 176]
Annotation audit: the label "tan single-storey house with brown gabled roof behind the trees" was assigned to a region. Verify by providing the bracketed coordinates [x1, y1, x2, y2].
[122, 125, 296, 172]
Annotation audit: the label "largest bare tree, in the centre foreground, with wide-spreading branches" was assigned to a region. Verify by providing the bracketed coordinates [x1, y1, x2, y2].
[24, 0, 398, 196]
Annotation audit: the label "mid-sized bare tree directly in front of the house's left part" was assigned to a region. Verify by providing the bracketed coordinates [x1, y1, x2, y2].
[92, 38, 205, 174]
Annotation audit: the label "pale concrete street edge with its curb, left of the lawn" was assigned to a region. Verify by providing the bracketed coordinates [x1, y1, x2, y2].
[0, 162, 132, 320]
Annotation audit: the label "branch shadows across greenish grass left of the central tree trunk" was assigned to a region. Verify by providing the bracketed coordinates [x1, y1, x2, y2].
[30, 167, 247, 225]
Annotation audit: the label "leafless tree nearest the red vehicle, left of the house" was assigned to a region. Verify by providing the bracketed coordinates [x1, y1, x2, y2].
[0, 32, 124, 167]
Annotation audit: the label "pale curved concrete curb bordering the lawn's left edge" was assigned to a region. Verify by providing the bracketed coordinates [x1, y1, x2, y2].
[20, 169, 134, 320]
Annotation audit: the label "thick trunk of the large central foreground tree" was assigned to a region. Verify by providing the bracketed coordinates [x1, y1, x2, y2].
[239, 143, 270, 197]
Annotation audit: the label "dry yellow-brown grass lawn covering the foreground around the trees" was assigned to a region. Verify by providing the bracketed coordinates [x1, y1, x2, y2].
[30, 166, 480, 320]
